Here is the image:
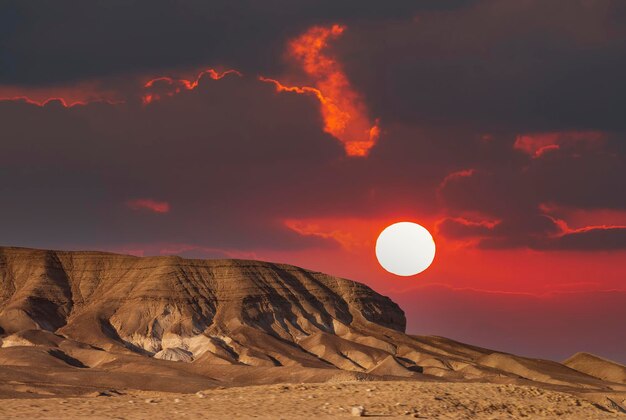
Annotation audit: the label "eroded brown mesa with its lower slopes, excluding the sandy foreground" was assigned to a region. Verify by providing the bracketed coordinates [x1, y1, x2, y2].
[0, 247, 626, 412]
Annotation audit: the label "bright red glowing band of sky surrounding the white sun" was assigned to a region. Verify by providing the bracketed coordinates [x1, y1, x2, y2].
[276, 214, 625, 296]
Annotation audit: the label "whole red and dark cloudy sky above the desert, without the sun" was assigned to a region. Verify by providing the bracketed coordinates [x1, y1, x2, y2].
[0, 0, 626, 362]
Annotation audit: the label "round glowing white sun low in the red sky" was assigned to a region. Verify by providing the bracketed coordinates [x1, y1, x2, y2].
[376, 222, 435, 276]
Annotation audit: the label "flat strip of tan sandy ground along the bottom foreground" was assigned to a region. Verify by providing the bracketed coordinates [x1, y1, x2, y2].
[0, 381, 626, 419]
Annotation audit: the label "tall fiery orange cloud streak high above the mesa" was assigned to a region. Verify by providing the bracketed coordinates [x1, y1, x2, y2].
[259, 25, 380, 156]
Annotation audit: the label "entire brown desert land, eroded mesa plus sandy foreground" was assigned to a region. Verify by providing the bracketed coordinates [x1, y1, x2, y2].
[0, 247, 626, 419]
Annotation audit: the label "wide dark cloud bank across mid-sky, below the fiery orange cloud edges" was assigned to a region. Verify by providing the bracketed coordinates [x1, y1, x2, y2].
[0, 84, 625, 253]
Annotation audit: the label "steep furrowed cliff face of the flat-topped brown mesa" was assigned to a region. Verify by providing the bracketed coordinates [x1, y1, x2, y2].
[0, 248, 406, 370]
